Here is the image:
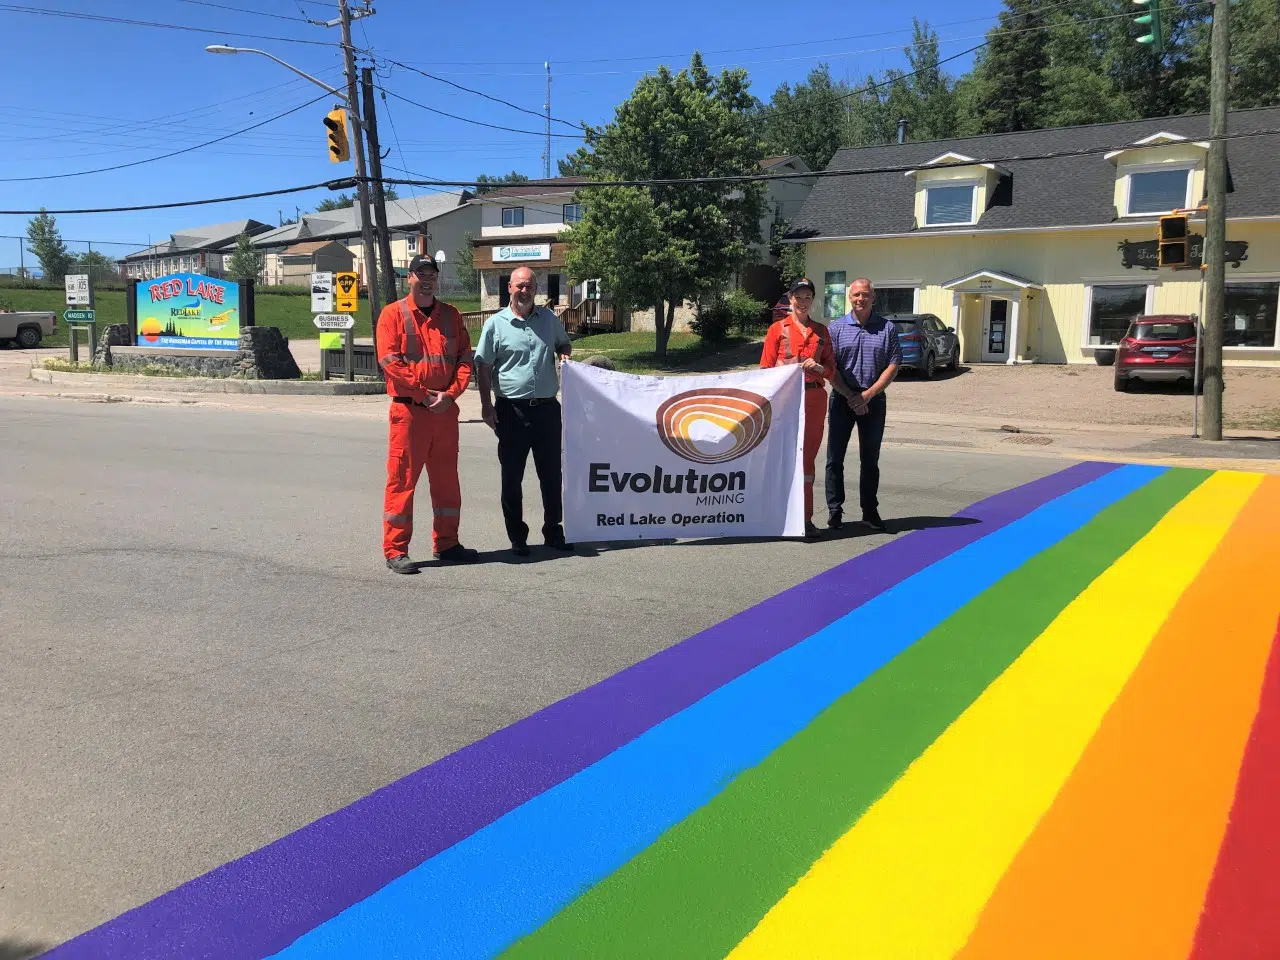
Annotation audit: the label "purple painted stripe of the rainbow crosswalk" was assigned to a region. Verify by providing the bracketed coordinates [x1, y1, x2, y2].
[45, 463, 1119, 960]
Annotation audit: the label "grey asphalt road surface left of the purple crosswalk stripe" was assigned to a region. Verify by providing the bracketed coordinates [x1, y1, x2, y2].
[0, 398, 1068, 956]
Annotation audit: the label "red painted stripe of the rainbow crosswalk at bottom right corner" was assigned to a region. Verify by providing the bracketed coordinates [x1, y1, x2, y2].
[1190, 619, 1280, 960]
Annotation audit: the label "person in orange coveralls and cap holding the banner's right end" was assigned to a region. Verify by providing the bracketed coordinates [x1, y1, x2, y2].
[760, 278, 836, 540]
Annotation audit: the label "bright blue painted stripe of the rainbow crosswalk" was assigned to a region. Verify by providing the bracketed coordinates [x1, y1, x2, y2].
[275, 466, 1165, 960]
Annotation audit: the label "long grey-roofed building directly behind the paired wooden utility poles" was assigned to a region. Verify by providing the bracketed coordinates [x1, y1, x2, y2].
[253, 191, 480, 294]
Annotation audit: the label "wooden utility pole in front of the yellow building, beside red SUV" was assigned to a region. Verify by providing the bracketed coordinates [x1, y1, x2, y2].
[1203, 0, 1230, 440]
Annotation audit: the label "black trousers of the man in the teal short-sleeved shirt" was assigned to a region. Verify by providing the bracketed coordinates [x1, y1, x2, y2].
[494, 397, 564, 544]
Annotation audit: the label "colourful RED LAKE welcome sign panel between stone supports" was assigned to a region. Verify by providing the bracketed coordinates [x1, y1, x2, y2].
[137, 274, 239, 349]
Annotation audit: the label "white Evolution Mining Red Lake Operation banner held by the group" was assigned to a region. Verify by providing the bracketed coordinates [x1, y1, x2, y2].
[561, 362, 804, 543]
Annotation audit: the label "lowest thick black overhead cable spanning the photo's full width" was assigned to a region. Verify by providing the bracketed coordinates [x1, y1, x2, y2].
[0, 126, 1280, 216]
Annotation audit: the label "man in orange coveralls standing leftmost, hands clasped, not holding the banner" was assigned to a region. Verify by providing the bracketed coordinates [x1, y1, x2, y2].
[378, 253, 479, 573]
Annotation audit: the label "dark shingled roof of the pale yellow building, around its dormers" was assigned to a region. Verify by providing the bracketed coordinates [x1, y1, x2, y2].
[788, 108, 1280, 239]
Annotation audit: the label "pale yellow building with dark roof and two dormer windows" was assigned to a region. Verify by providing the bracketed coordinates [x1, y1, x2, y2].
[790, 108, 1280, 366]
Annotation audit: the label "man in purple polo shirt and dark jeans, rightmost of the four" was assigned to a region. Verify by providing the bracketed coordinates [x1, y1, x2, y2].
[827, 279, 902, 530]
